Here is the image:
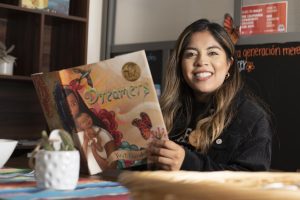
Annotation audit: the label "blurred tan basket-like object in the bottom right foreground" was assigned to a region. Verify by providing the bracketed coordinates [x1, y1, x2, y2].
[118, 171, 300, 200]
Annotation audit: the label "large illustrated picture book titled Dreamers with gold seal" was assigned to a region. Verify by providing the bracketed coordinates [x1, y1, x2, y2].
[31, 51, 167, 174]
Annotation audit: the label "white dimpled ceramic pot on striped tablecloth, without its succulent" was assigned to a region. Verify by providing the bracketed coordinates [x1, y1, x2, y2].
[35, 150, 80, 190]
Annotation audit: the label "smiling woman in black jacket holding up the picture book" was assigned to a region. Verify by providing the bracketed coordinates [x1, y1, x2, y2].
[149, 19, 273, 171]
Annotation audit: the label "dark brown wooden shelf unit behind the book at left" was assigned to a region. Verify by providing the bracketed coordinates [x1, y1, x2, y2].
[0, 0, 89, 140]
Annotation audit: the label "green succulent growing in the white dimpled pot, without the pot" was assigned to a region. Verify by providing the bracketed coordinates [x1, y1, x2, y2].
[40, 129, 76, 151]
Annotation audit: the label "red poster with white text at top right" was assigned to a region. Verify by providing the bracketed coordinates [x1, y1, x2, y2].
[241, 1, 288, 35]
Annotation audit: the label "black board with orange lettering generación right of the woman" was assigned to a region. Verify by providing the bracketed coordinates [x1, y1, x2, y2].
[236, 42, 300, 171]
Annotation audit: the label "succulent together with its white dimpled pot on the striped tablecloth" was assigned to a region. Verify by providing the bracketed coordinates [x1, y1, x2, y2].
[33, 129, 80, 190]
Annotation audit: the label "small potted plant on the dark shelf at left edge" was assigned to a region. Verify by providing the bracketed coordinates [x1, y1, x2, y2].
[0, 41, 16, 75]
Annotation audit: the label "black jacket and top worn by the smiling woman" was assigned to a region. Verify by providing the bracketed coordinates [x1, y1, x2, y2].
[170, 91, 273, 171]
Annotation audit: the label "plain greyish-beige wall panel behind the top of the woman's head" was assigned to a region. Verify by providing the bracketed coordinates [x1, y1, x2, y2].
[114, 0, 234, 45]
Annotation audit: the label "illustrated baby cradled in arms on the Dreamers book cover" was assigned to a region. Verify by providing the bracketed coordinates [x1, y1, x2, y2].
[75, 112, 115, 170]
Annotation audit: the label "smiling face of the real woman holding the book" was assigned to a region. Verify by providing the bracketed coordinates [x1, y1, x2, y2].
[181, 31, 232, 101]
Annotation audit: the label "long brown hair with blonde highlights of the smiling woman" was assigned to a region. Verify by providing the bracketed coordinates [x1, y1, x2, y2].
[160, 19, 242, 152]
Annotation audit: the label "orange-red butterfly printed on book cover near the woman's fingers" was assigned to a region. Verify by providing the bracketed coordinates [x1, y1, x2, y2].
[132, 112, 152, 140]
